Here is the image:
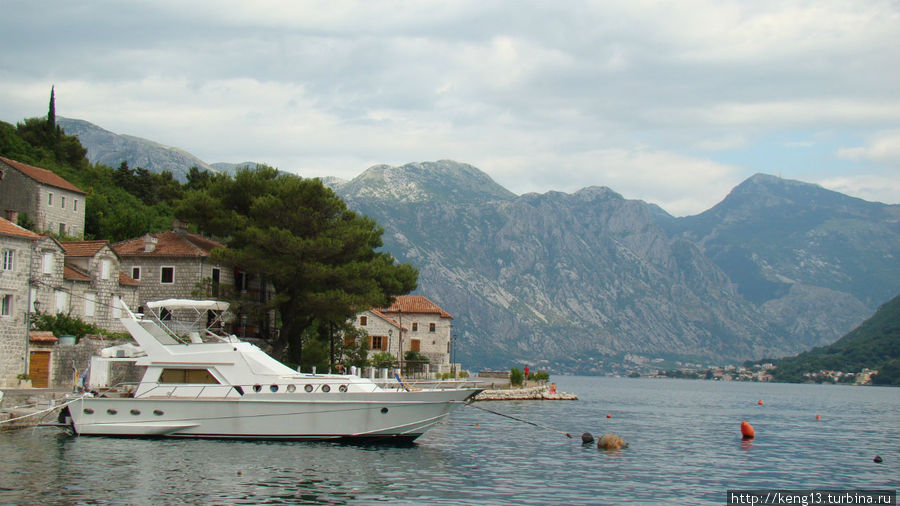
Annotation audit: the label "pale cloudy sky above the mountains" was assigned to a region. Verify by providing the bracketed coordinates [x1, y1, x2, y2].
[0, 0, 900, 216]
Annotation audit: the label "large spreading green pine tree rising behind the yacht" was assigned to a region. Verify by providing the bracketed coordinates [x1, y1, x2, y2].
[176, 166, 418, 364]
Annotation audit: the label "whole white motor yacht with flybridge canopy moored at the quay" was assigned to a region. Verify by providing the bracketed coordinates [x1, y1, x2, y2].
[59, 299, 481, 441]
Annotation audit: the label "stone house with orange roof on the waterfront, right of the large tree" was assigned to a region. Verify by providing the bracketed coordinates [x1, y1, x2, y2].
[354, 295, 453, 373]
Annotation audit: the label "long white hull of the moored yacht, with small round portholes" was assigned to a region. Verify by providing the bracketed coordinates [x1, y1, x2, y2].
[69, 389, 480, 440]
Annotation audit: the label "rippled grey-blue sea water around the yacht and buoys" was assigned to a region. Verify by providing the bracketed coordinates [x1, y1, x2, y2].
[0, 377, 900, 504]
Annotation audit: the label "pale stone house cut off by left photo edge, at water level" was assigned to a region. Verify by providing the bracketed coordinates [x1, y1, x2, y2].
[0, 218, 41, 387]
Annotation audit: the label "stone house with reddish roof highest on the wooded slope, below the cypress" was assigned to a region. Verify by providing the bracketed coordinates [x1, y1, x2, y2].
[0, 157, 86, 237]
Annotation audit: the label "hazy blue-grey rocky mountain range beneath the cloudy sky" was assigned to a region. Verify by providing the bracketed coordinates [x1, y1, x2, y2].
[60, 120, 900, 374]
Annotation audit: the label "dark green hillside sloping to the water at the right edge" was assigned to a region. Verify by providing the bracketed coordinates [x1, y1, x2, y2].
[774, 295, 900, 386]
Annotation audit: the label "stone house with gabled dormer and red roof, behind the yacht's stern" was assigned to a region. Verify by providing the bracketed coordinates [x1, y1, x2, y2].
[61, 241, 140, 332]
